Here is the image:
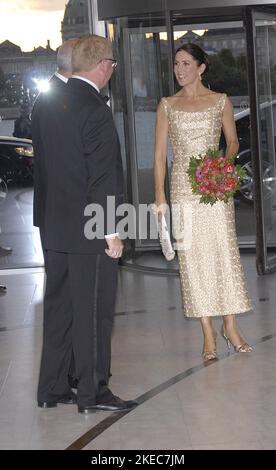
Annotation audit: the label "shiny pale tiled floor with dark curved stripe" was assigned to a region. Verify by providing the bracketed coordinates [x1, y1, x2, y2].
[0, 254, 276, 450]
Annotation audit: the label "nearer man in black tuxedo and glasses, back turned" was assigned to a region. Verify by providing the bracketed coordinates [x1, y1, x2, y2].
[32, 35, 137, 413]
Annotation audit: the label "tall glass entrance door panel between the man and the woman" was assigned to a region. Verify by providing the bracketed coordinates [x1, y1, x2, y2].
[119, 21, 170, 250]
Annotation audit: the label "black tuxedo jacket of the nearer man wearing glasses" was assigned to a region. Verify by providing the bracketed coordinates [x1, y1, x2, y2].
[32, 77, 123, 253]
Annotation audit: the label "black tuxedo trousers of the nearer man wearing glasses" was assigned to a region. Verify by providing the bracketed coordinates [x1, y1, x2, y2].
[37, 250, 118, 406]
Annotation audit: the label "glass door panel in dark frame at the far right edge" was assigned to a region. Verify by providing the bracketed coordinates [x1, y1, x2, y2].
[249, 10, 276, 274]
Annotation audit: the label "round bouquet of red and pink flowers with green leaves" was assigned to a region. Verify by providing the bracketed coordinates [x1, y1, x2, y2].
[187, 149, 246, 205]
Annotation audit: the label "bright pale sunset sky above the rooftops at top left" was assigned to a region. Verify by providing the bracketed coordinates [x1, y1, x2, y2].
[0, 0, 68, 51]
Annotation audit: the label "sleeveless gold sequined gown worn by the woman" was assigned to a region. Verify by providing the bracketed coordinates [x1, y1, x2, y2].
[162, 94, 251, 317]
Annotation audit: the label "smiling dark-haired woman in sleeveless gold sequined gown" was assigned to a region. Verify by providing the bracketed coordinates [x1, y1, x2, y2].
[154, 43, 252, 360]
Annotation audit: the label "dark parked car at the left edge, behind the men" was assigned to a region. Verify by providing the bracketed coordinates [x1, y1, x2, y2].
[0, 136, 34, 186]
